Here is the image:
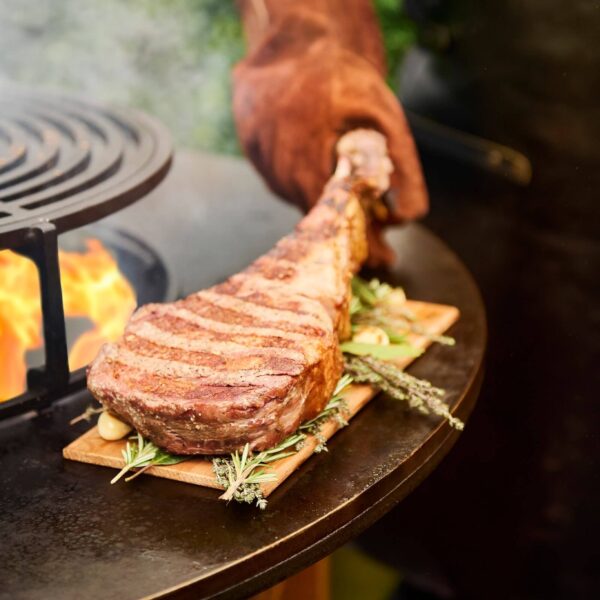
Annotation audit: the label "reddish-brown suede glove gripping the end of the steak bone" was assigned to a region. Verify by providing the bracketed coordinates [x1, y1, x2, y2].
[233, 0, 427, 265]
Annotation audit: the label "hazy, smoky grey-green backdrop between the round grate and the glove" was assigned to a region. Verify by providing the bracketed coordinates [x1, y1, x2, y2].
[0, 0, 242, 152]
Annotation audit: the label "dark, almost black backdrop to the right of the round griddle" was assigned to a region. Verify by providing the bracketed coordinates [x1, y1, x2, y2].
[364, 0, 600, 599]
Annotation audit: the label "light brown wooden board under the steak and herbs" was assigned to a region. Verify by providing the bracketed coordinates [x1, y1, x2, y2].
[63, 300, 459, 496]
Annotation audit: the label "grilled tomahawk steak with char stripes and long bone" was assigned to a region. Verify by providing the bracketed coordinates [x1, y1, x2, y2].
[88, 131, 387, 454]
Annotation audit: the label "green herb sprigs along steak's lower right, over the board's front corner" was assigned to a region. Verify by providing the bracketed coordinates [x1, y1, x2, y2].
[212, 375, 352, 509]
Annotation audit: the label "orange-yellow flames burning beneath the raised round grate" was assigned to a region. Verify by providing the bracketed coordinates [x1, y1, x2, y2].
[0, 239, 136, 401]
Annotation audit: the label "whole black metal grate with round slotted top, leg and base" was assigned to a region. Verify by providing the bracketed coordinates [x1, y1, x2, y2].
[0, 88, 172, 418]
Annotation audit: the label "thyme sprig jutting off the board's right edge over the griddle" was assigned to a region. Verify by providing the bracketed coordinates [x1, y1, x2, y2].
[345, 356, 464, 430]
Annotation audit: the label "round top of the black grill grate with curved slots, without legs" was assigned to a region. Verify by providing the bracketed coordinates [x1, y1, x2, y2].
[0, 89, 171, 248]
